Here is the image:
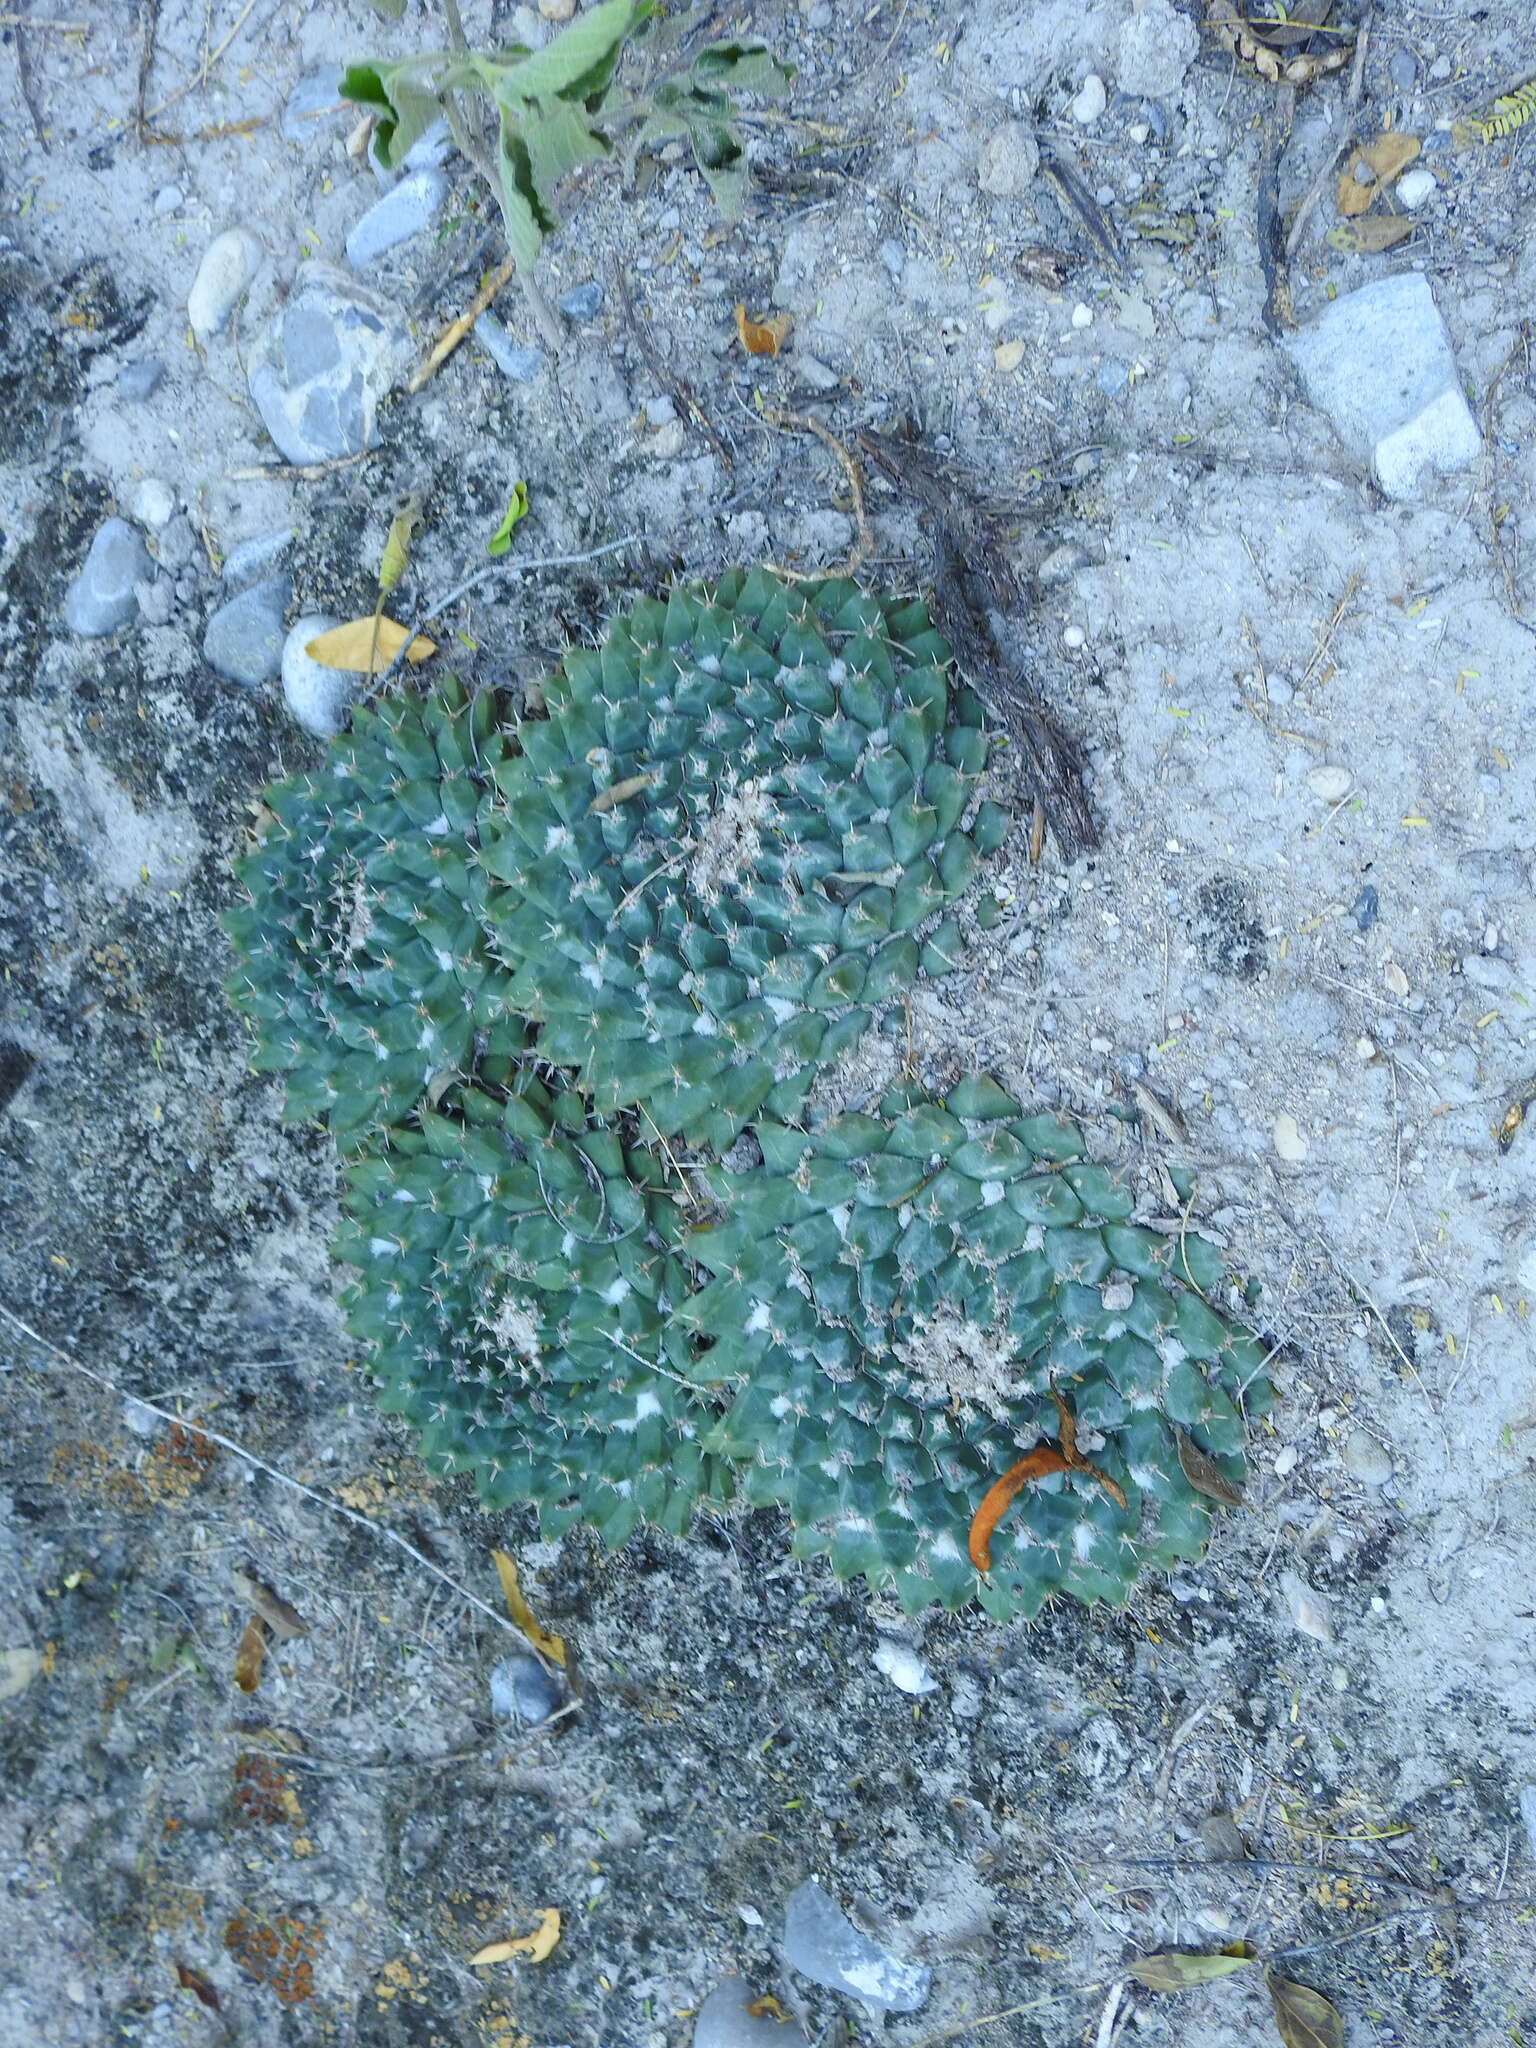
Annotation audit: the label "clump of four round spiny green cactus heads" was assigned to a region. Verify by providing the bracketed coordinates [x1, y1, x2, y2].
[227, 571, 1268, 1616]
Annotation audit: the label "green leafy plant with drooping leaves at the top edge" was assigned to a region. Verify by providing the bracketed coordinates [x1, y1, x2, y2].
[342, 0, 793, 274]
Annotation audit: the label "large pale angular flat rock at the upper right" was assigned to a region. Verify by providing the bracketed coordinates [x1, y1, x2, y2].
[1286, 270, 1483, 498]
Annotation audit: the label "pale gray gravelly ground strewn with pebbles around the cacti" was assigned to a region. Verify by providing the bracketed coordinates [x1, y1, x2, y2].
[0, 0, 1536, 2048]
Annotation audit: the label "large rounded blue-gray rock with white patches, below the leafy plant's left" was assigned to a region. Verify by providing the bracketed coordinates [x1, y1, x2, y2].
[248, 264, 412, 463]
